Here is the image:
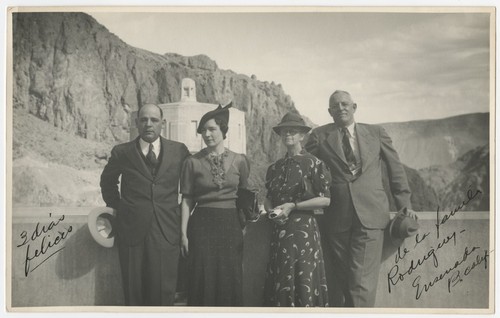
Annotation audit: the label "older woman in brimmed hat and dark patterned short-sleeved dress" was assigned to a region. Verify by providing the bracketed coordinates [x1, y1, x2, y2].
[264, 113, 331, 307]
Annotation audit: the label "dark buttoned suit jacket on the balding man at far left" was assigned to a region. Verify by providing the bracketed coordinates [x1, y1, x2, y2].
[100, 137, 189, 246]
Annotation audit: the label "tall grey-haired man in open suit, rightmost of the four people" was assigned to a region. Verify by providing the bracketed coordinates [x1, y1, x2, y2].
[305, 91, 416, 307]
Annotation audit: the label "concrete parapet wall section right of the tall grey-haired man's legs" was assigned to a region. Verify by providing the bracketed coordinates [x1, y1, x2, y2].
[376, 212, 493, 308]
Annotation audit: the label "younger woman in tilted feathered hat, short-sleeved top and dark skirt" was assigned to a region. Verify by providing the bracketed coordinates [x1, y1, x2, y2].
[181, 105, 249, 306]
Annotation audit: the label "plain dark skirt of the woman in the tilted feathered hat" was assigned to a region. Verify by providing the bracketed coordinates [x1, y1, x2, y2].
[187, 208, 243, 306]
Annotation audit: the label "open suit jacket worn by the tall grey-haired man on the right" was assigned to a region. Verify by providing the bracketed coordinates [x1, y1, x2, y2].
[305, 123, 411, 232]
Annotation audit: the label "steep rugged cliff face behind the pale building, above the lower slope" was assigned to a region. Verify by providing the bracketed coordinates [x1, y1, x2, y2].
[13, 13, 297, 161]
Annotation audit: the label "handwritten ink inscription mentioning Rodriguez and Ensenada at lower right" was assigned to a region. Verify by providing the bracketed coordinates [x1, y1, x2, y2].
[387, 187, 492, 300]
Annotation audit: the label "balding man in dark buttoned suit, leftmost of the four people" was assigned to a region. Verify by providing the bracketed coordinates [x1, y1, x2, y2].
[100, 104, 189, 306]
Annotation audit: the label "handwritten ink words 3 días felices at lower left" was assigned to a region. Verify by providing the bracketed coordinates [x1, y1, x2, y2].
[17, 213, 73, 277]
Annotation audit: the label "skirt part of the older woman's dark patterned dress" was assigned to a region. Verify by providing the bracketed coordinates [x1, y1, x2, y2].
[264, 213, 328, 307]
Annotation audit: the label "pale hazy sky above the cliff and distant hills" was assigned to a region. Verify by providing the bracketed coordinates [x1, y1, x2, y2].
[90, 12, 490, 125]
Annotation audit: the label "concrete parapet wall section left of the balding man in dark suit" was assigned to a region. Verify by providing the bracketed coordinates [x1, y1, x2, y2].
[11, 208, 123, 307]
